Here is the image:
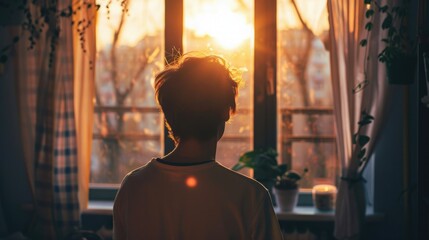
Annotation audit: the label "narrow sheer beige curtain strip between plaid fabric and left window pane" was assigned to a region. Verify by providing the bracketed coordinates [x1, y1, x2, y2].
[73, 0, 97, 210]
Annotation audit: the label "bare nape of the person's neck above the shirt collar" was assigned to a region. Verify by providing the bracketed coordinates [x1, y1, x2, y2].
[162, 139, 217, 163]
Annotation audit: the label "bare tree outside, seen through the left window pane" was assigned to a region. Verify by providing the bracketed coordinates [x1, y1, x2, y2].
[96, 1, 160, 182]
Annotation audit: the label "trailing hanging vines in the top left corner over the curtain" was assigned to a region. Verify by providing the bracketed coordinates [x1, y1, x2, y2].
[0, 0, 128, 68]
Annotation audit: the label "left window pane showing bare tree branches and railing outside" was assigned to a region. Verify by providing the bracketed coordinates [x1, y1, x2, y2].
[91, 0, 164, 183]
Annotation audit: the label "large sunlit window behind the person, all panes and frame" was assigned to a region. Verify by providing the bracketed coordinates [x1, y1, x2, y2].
[91, 0, 339, 191]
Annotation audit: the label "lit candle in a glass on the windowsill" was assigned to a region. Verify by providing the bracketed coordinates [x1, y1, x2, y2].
[313, 184, 337, 211]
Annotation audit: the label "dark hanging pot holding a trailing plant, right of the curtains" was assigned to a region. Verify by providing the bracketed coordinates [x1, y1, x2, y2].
[386, 53, 417, 85]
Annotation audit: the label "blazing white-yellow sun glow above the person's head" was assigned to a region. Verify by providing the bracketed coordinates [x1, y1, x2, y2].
[185, 1, 253, 50]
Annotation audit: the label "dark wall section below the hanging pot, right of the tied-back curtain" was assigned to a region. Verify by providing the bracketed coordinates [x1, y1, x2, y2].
[368, 87, 404, 240]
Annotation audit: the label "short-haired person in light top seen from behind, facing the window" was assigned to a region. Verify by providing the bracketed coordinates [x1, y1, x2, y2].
[113, 55, 282, 240]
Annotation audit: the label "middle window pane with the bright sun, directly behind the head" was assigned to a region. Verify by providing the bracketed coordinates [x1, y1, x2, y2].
[183, 0, 254, 167]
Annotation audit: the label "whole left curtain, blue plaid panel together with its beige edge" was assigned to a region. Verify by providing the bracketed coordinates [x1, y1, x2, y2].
[15, 0, 96, 239]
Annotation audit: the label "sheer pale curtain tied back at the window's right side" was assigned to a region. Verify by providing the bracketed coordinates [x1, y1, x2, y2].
[328, 0, 388, 239]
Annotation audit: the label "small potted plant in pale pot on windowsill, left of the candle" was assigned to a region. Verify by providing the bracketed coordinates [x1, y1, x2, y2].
[273, 168, 308, 212]
